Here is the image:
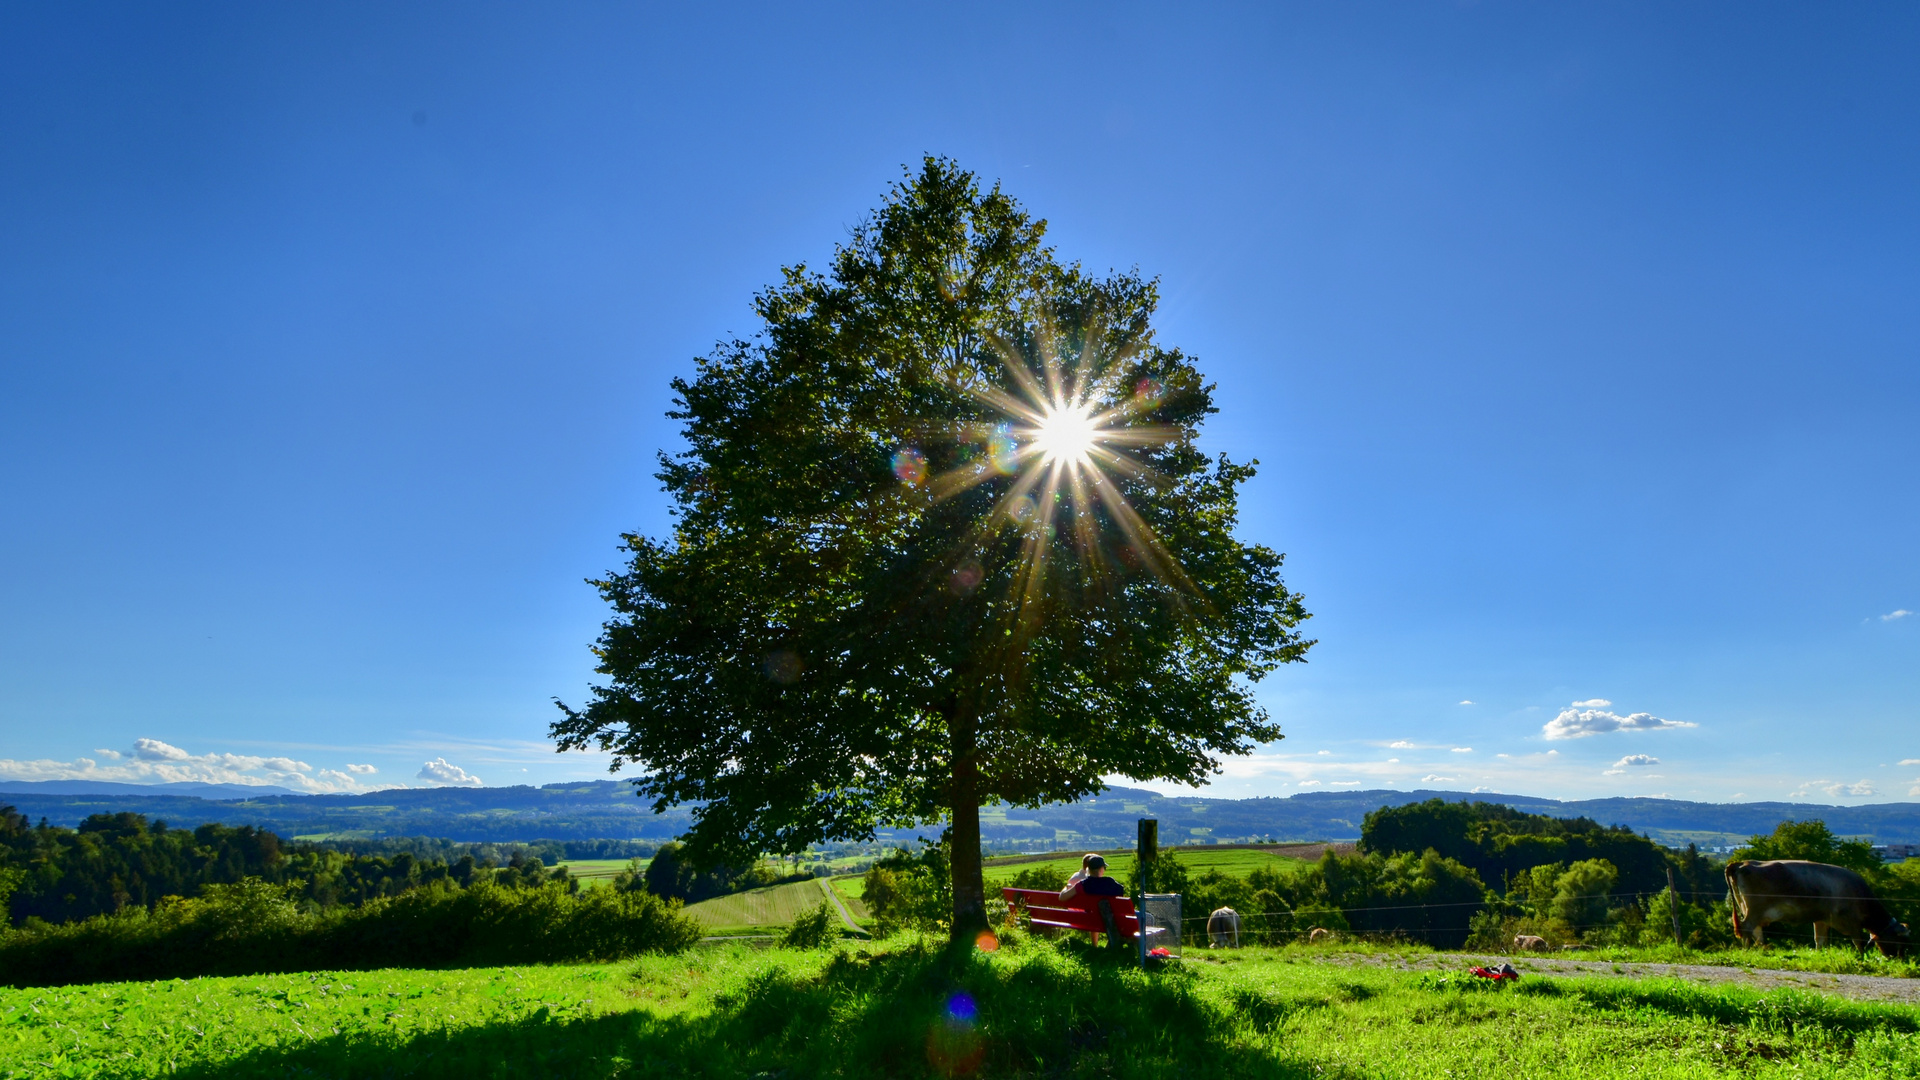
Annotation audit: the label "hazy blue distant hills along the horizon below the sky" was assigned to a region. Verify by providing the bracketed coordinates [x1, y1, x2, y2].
[0, 780, 1920, 849]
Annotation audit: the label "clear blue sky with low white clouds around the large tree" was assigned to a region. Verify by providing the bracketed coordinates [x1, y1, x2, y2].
[0, 4, 1920, 801]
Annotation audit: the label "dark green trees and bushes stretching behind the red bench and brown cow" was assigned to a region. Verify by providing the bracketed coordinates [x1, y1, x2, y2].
[866, 799, 1920, 949]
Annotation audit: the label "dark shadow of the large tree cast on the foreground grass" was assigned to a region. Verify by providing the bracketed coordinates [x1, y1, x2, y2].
[179, 947, 1325, 1080]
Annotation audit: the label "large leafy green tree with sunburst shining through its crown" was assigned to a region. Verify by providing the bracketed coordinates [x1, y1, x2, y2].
[553, 158, 1311, 938]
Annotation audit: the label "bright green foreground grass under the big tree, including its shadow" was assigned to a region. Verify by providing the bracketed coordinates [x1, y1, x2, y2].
[0, 936, 1920, 1080]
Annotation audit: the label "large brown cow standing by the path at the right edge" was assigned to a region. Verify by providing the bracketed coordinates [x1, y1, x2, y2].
[1726, 859, 1907, 957]
